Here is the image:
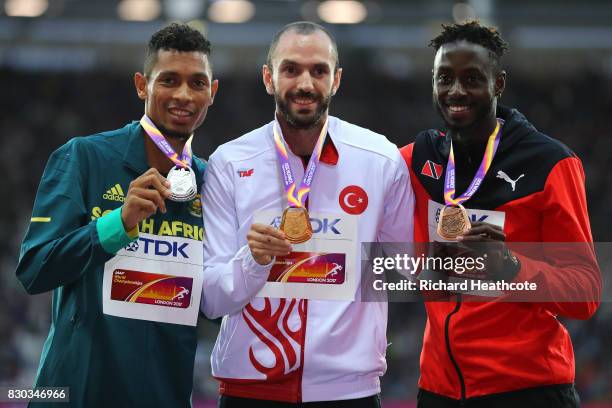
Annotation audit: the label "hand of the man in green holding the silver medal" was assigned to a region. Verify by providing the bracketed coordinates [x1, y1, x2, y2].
[121, 168, 170, 231]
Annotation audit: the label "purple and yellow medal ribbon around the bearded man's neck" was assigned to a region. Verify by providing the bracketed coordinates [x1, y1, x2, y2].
[273, 118, 327, 207]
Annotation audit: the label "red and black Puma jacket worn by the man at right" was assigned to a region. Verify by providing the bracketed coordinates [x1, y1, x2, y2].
[401, 108, 600, 399]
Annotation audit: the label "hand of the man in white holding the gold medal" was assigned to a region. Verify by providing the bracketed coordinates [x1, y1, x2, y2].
[247, 223, 291, 265]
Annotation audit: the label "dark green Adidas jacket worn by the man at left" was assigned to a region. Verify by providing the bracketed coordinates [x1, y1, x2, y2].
[17, 122, 205, 408]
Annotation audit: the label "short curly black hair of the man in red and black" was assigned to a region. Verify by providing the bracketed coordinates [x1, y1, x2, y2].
[429, 20, 508, 67]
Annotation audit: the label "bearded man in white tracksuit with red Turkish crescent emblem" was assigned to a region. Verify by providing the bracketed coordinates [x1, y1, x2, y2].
[202, 22, 414, 408]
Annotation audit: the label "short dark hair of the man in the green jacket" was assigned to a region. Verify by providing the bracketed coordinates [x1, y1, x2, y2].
[144, 23, 211, 76]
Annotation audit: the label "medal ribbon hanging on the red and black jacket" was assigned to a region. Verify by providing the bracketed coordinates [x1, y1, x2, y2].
[444, 119, 504, 206]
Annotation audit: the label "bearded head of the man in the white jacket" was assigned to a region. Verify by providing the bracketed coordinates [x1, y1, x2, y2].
[263, 30, 342, 129]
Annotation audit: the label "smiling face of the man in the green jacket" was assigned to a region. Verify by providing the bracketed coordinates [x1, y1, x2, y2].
[134, 50, 218, 139]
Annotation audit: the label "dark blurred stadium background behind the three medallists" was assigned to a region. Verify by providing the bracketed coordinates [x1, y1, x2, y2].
[0, 0, 612, 407]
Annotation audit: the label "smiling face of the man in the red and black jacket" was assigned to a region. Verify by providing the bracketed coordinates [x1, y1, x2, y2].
[432, 40, 506, 129]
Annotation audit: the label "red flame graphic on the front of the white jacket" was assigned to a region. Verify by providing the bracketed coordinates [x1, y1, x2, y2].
[242, 298, 305, 380]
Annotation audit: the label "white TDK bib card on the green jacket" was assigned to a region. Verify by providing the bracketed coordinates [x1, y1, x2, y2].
[102, 233, 203, 326]
